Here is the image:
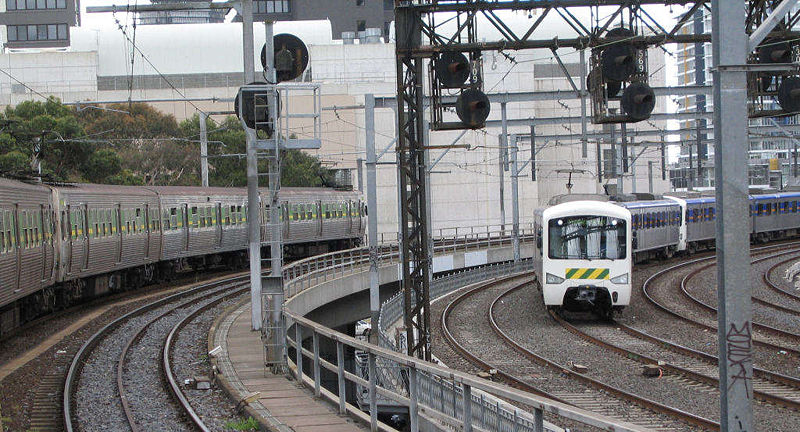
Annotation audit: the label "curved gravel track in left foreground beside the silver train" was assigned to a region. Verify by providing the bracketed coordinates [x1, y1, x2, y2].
[63, 276, 247, 432]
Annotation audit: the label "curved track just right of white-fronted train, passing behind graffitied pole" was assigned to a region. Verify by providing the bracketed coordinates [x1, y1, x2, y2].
[642, 242, 800, 356]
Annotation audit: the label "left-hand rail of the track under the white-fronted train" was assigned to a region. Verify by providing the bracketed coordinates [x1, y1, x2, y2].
[550, 310, 800, 409]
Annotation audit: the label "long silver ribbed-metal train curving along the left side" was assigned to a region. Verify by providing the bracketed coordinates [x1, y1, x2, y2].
[0, 178, 367, 336]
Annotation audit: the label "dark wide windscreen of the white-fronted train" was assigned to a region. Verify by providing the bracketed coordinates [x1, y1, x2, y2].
[548, 216, 627, 259]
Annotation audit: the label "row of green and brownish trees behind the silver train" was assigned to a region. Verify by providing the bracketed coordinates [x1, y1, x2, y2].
[0, 98, 333, 187]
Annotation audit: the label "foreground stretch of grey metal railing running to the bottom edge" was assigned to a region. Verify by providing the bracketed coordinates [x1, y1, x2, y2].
[285, 310, 646, 432]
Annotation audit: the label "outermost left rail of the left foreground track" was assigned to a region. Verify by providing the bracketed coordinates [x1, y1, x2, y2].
[62, 276, 248, 432]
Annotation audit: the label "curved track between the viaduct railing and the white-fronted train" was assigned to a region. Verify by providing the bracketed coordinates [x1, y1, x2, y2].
[440, 280, 719, 431]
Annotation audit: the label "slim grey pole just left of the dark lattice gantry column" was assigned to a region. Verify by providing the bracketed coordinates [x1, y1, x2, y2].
[368, 94, 381, 343]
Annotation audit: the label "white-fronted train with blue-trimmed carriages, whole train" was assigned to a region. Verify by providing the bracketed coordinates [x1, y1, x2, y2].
[534, 192, 800, 317]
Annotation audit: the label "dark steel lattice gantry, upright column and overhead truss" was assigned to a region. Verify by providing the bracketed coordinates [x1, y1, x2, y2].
[395, 0, 711, 359]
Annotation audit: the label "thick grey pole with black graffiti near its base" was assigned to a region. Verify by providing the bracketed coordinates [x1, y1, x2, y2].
[711, 0, 754, 431]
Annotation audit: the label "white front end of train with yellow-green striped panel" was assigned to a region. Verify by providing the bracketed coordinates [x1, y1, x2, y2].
[534, 200, 633, 317]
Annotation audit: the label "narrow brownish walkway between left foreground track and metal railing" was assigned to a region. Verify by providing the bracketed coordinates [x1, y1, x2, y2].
[220, 303, 364, 432]
